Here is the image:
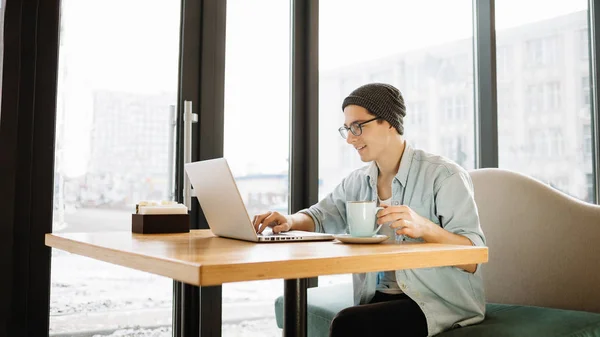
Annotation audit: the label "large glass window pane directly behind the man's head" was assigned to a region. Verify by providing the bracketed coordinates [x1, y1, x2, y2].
[319, 0, 475, 284]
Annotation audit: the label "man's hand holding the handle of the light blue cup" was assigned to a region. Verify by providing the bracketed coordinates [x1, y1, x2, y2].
[377, 205, 435, 238]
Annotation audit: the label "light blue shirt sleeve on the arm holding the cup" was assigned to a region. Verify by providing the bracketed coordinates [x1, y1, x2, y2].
[435, 171, 486, 246]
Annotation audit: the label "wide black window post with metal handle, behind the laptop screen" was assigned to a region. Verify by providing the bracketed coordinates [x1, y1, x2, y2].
[173, 0, 227, 337]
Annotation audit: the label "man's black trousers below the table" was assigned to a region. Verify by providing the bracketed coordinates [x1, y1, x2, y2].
[329, 292, 427, 337]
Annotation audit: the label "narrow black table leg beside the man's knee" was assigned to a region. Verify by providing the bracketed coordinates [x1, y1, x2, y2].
[283, 278, 308, 337]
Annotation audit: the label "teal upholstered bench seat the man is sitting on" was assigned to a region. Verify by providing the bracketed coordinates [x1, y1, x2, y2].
[275, 284, 600, 337]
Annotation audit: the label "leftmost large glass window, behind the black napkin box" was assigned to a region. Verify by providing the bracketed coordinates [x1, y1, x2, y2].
[50, 0, 181, 336]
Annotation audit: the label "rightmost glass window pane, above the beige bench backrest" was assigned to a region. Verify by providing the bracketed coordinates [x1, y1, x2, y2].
[496, 0, 593, 202]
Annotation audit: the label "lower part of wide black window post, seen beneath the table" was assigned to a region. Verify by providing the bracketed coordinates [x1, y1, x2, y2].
[179, 284, 223, 337]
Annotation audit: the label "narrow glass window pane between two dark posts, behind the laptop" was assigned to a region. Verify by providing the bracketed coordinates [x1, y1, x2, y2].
[223, 0, 291, 336]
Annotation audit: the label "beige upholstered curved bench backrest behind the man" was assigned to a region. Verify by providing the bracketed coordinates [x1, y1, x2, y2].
[469, 169, 600, 312]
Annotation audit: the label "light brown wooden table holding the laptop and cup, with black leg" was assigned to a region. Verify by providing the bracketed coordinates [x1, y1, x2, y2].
[46, 230, 488, 336]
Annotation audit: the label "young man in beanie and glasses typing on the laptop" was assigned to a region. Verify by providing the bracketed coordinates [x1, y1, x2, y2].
[254, 83, 485, 337]
